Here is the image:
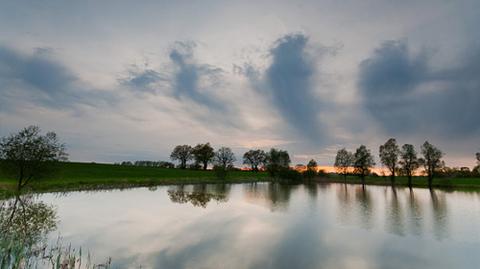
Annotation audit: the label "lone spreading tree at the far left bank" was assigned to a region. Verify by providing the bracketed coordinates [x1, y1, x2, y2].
[0, 126, 67, 191]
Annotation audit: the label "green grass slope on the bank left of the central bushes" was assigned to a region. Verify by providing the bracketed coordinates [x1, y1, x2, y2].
[0, 162, 268, 192]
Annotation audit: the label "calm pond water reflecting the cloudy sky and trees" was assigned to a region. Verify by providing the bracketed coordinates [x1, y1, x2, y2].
[0, 183, 480, 269]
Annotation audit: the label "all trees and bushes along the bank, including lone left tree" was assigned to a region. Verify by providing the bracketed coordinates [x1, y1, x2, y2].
[0, 126, 480, 190]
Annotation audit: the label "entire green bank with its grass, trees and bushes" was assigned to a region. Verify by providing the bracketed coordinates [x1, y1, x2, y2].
[0, 126, 480, 193]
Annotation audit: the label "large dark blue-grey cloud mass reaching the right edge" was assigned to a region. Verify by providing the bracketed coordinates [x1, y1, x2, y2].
[358, 41, 480, 137]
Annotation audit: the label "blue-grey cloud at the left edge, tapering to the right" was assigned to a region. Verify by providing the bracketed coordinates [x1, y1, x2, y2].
[0, 46, 115, 109]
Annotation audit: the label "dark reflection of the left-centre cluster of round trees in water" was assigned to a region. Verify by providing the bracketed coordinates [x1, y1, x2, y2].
[167, 184, 230, 208]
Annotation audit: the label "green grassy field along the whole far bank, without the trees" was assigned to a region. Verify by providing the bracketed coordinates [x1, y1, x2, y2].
[0, 162, 480, 193]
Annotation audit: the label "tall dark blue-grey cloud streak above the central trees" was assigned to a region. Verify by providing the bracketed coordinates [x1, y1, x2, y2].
[246, 34, 326, 142]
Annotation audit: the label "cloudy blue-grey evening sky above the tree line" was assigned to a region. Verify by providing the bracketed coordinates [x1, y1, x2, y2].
[0, 0, 480, 167]
